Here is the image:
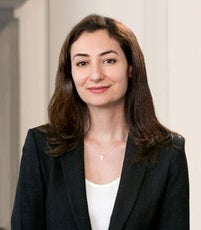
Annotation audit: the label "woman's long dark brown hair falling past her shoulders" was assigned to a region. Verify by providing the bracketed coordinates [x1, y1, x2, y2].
[43, 15, 171, 160]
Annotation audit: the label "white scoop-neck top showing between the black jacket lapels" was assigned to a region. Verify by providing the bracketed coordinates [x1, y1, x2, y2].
[86, 178, 120, 230]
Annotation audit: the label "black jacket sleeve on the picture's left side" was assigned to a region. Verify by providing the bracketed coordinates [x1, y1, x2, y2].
[11, 130, 46, 230]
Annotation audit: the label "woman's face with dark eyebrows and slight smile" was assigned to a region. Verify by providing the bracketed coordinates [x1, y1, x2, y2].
[70, 30, 131, 108]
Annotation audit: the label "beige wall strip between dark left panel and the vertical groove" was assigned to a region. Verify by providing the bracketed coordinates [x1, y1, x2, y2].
[15, 0, 48, 151]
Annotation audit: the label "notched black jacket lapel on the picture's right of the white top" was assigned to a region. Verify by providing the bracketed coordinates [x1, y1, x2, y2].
[109, 137, 147, 230]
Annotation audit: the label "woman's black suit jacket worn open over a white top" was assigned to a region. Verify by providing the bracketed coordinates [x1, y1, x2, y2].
[11, 128, 189, 230]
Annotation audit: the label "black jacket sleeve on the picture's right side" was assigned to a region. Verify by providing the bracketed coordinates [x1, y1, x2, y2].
[158, 137, 189, 230]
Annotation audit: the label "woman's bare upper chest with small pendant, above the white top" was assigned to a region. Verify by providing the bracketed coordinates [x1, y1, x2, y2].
[84, 138, 126, 184]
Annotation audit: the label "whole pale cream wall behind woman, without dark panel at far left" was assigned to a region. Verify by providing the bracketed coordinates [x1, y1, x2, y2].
[16, 0, 201, 230]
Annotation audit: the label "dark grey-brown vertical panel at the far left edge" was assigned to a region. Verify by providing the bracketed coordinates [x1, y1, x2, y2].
[0, 20, 20, 229]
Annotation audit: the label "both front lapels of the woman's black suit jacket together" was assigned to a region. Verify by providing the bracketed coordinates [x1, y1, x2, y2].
[61, 137, 146, 230]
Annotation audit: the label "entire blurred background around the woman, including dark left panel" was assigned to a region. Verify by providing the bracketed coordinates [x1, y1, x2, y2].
[0, 0, 201, 230]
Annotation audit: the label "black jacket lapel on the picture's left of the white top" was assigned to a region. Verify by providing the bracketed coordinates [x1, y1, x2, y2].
[61, 144, 91, 230]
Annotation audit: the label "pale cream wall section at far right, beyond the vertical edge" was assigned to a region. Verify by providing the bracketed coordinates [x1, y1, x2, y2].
[167, 0, 201, 230]
